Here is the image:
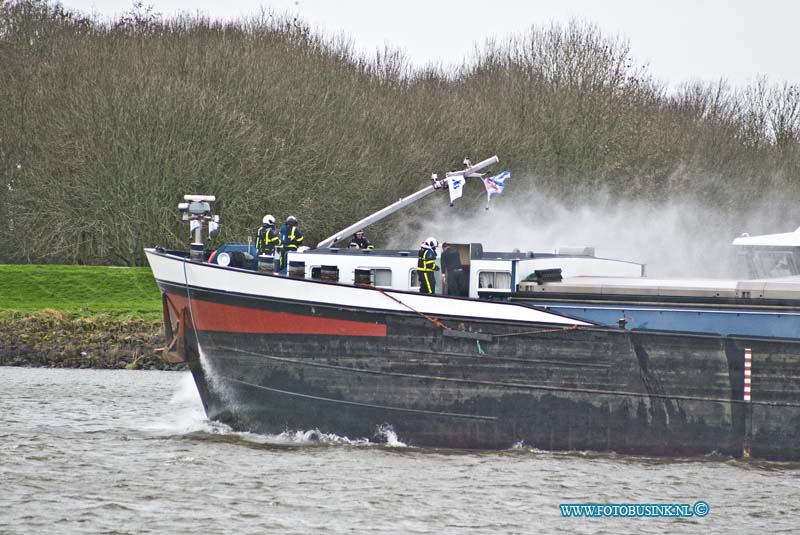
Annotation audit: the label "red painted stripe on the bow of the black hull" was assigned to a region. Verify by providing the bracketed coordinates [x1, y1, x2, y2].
[167, 294, 386, 336]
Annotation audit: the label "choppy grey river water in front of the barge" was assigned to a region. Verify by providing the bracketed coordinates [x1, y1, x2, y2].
[0, 367, 800, 535]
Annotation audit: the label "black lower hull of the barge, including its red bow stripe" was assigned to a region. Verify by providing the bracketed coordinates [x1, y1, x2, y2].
[150, 260, 800, 460]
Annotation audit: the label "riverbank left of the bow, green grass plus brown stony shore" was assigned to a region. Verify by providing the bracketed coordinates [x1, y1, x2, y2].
[0, 265, 170, 368]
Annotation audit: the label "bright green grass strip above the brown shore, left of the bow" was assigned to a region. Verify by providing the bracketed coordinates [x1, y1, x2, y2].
[0, 264, 161, 319]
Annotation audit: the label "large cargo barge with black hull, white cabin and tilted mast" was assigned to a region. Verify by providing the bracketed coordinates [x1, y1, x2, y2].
[146, 157, 800, 460]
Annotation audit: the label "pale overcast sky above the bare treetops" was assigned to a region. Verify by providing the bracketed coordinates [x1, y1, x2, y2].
[62, 0, 800, 87]
